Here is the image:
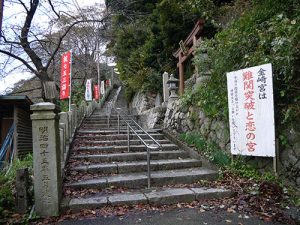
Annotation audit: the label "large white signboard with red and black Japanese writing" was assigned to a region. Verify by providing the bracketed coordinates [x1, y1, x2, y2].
[227, 64, 275, 157]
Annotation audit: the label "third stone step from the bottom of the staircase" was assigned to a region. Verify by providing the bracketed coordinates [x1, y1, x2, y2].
[71, 159, 202, 174]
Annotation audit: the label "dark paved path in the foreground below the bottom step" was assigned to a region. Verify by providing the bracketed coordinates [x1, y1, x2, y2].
[59, 209, 280, 225]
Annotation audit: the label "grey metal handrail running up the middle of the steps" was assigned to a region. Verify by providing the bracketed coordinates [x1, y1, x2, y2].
[112, 108, 162, 188]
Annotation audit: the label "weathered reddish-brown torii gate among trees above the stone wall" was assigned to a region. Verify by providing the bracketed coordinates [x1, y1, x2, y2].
[173, 20, 204, 95]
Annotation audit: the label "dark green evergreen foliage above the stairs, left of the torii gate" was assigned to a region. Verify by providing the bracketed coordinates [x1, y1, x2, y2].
[107, 0, 215, 98]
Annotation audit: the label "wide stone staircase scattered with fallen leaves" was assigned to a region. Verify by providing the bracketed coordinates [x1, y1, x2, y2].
[62, 89, 231, 211]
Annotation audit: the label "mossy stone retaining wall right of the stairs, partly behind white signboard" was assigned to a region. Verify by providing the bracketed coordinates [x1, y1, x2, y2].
[163, 100, 300, 187]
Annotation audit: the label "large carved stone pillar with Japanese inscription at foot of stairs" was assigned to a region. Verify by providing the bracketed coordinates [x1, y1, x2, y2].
[30, 102, 62, 217]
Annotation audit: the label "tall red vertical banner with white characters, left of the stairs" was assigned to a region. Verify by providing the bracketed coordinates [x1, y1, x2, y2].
[60, 51, 71, 99]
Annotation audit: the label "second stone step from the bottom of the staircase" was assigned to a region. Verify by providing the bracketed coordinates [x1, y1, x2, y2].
[65, 168, 218, 189]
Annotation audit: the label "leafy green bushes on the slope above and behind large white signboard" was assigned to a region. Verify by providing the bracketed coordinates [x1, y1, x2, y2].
[189, 0, 300, 128]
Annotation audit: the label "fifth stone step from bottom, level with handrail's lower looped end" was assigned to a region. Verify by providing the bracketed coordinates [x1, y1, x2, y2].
[77, 144, 179, 153]
